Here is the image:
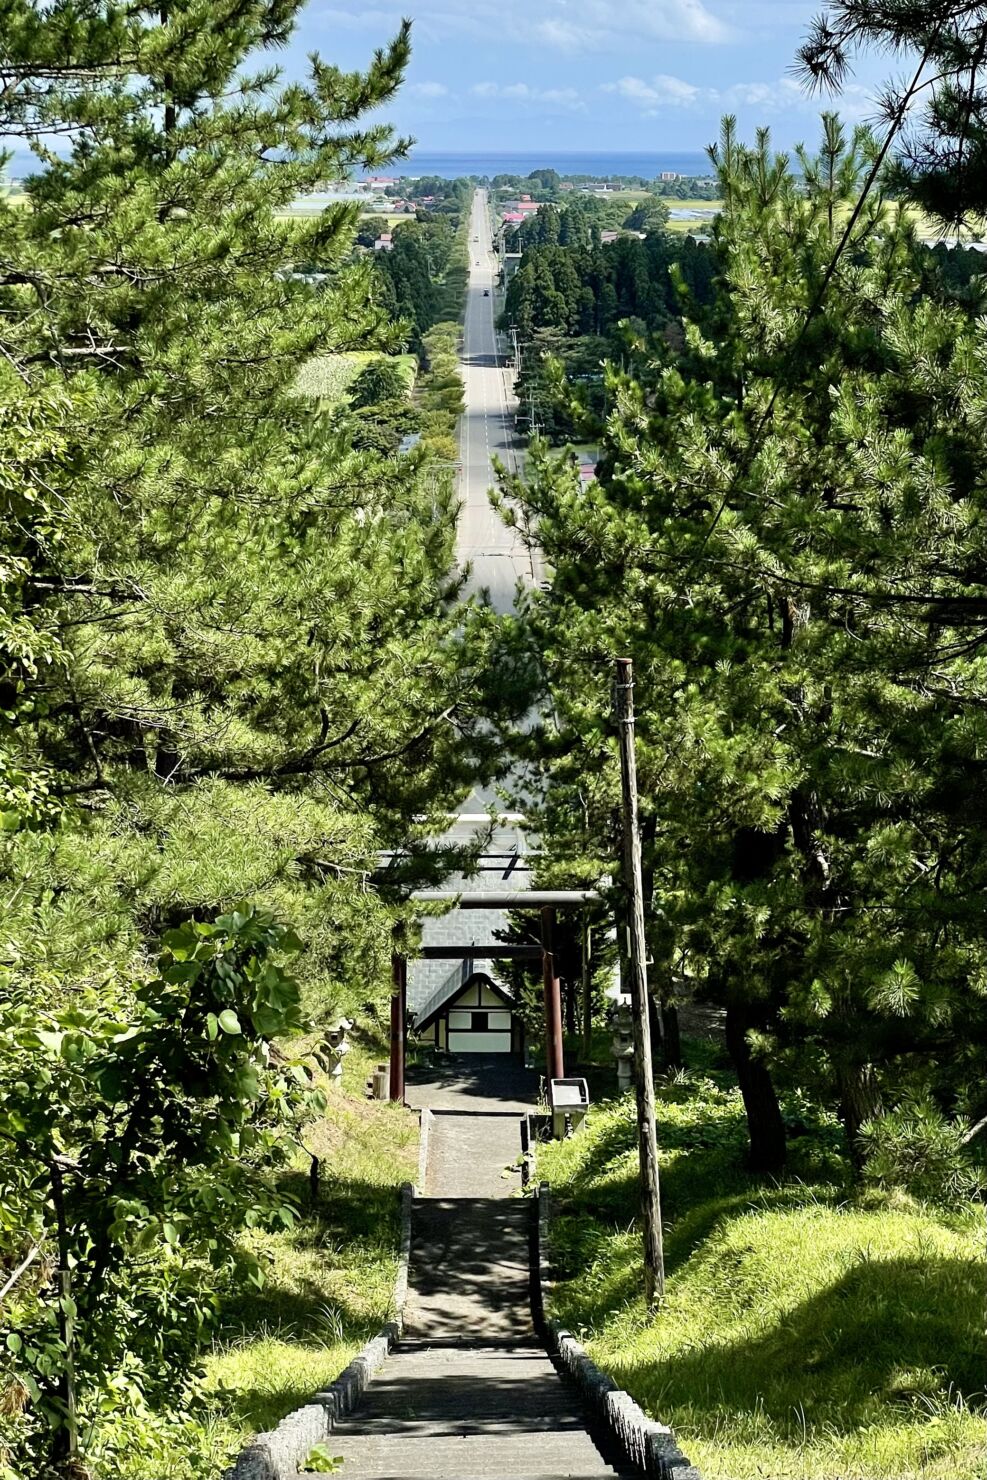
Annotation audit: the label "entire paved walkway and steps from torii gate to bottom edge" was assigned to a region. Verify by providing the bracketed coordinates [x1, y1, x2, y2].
[331, 1055, 627, 1480]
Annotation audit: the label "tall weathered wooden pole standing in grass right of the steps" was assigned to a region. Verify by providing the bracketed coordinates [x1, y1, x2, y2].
[614, 657, 664, 1310]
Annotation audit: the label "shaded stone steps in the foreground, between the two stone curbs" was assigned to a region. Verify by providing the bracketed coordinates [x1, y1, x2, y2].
[330, 1197, 629, 1480]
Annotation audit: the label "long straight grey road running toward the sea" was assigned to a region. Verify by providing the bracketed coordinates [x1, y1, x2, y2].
[456, 189, 534, 613]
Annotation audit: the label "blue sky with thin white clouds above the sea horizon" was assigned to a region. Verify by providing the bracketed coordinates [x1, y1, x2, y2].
[287, 0, 888, 149]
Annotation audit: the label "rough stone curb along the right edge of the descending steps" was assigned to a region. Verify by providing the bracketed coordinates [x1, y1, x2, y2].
[534, 1183, 701, 1480]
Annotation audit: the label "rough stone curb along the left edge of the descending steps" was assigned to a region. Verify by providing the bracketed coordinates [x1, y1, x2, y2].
[223, 1183, 414, 1480]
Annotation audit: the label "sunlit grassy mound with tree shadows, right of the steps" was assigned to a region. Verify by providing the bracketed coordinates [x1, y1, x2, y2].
[539, 1074, 987, 1480]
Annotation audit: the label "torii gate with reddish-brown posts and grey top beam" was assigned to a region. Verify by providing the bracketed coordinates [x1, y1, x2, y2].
[389, 889, 599, 1103]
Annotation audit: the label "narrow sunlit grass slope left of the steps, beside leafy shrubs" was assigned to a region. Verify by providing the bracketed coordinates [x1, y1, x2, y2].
[133, 1043, 417, 1480]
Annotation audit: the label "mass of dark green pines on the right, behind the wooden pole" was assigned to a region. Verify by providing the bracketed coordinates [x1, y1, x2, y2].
[509, 117, 987, 1202]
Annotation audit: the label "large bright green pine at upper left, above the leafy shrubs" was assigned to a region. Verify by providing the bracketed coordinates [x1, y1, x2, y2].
[0, 3, 509, 1006]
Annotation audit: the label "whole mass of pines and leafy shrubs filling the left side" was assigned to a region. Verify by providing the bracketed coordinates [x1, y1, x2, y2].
[0, 0, 500, 1477]
